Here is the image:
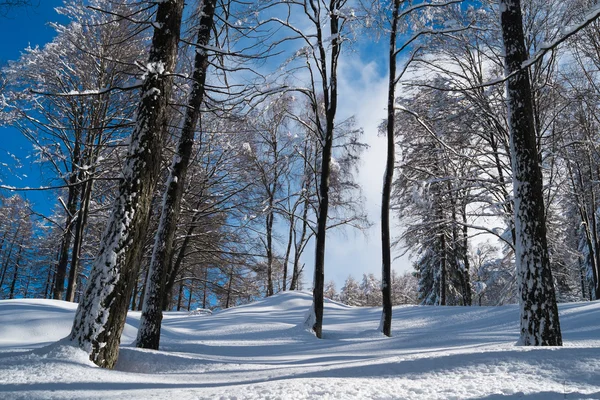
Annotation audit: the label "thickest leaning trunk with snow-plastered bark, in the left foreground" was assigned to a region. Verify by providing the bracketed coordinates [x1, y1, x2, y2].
[70, 0, 184, 368]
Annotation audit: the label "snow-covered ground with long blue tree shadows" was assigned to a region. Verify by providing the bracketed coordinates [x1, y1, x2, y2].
[0, 292, 600, 400]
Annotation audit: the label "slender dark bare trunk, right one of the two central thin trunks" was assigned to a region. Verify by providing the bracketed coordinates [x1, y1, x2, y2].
[380, 0, 400, 337]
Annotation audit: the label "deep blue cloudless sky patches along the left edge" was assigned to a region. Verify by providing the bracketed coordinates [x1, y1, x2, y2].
[0, 0, 62, 213]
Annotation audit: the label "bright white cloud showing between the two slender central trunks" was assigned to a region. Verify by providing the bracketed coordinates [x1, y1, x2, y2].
[304, 53, 411, 290]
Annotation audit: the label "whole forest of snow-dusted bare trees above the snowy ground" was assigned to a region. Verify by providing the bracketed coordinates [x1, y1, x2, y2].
[0, 0, 600, 368]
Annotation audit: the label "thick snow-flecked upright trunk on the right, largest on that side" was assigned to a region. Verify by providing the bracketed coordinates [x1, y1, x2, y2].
[500, 0, 562, 346]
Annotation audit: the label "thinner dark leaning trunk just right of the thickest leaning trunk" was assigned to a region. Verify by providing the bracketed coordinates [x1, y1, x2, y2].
[136, 0, 216, 350]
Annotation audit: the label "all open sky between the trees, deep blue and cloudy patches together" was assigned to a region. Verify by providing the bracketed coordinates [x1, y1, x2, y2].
[0, 0, 410, 290]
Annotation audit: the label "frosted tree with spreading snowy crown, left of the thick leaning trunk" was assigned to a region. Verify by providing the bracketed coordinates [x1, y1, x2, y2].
[4, 0, 144, 301]
